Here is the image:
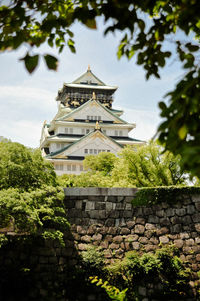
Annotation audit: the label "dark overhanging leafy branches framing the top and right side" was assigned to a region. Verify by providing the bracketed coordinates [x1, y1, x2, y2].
[0, 0, 200, 176]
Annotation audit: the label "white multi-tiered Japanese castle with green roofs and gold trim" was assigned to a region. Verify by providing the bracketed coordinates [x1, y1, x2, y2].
[40, 66, 144, 175]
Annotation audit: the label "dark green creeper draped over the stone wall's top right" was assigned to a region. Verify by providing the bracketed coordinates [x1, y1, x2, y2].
[132, 186, 200, 206]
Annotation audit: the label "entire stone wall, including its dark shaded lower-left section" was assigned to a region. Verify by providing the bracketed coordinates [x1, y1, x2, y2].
[0, 188, 200, 301]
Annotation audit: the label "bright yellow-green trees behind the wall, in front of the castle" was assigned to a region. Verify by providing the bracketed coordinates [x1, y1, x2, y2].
[59, 143, 186, 187]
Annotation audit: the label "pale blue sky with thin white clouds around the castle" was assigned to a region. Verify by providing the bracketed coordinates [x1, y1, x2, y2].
[0, 18, 182, 147]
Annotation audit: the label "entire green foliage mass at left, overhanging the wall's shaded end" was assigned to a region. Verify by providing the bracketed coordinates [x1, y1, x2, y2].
[0, 139, 69, 247]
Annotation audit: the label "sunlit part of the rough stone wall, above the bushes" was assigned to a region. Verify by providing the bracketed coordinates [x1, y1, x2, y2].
[65, 188, 200, 272]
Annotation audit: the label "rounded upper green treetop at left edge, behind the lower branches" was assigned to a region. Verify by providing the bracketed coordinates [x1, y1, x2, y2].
[0, 140, 56, 190]
